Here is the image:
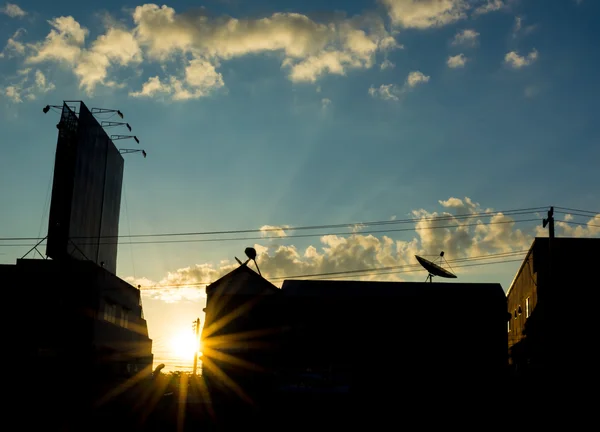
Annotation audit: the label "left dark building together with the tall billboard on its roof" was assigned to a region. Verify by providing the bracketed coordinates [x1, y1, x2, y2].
[0, 101, 153, 398]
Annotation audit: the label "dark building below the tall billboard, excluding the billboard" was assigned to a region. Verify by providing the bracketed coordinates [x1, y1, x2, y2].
[0, 259, 153, 378]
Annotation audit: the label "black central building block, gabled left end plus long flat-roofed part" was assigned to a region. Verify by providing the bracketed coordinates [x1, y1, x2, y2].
[202, 266, 508, 415]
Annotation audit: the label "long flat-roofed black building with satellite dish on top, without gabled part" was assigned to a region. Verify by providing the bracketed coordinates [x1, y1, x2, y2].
[282, 280, 507, 405]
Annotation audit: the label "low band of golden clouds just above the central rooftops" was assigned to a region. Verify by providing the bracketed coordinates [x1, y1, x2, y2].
[130, 197, 568, 301]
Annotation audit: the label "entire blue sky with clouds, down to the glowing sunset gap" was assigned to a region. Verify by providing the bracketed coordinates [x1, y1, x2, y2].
[0, 0, 600, 369]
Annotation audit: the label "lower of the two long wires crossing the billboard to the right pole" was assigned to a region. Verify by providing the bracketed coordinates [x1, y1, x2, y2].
[0, 218, 539, 247]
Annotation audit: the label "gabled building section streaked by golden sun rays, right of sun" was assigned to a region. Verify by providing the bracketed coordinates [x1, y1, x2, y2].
[201, 265, 280, 402]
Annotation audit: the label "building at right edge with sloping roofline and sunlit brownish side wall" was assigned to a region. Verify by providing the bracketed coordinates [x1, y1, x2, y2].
[507, 237, 600, 387]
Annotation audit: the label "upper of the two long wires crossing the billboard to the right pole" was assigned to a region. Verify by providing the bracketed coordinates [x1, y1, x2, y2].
[0, 207, 545, 241]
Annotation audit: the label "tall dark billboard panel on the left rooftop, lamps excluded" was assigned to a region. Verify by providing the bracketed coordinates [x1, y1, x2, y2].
[46, 102, 123, 273]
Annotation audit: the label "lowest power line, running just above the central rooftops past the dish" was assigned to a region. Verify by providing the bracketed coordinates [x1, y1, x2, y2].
[142, 250, 528, 289]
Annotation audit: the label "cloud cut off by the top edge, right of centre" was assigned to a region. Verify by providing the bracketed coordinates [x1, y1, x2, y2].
[381, 0, 469, 29]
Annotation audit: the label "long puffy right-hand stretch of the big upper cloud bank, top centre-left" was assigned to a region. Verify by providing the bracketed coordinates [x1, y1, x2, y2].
[133, 4, 398, 82]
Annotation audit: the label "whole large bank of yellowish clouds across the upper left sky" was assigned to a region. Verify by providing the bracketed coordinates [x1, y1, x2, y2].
[5, 4, 400, 100]
